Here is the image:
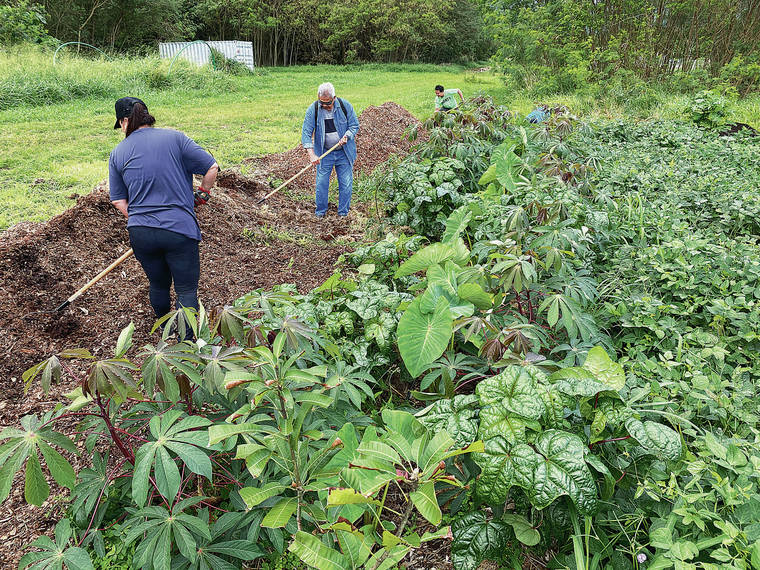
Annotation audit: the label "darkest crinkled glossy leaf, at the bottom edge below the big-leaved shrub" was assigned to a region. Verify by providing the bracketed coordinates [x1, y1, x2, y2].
[451, 512, 511, 570]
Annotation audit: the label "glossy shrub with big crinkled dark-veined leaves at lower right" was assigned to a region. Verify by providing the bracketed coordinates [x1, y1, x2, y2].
[422, 347, 682, 570]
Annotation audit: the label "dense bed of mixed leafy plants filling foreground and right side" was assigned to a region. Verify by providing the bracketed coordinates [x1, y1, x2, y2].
[5, 94, 760, 570]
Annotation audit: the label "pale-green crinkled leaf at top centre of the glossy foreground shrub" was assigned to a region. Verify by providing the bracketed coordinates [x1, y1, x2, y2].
[476, 366, 544, 443]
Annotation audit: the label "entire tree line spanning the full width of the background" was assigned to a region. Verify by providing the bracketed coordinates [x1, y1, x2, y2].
[0, 0, 760, 92]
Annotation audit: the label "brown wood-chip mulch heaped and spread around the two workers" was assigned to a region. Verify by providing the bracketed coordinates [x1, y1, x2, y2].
[0, 103, 424, 569]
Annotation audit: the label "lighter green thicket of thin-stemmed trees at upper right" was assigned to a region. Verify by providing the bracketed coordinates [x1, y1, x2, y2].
[483, 0, 760, 90]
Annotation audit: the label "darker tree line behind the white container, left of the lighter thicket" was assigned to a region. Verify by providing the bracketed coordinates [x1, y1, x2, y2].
[0, 0, 492, 65]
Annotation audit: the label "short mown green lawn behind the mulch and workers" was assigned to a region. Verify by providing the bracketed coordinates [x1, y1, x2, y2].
[0, 55, 506, 229]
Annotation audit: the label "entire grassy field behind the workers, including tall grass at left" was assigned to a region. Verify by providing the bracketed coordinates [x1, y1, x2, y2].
[0, 46, 760, 230]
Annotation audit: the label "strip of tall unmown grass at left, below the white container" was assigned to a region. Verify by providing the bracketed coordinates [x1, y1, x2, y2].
[0, 46, 234, 110]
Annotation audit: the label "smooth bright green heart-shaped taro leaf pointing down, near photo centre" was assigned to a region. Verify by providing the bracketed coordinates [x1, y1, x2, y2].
[397, 297, 453, 378]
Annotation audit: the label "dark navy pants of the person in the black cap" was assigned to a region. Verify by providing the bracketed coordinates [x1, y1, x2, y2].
[128, 226, 201, 318]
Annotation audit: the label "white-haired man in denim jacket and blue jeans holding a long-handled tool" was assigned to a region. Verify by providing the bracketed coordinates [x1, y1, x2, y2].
[301, 83, 359, 218]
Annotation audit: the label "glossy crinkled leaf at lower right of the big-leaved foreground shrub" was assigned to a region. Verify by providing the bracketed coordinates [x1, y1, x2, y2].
[525, 430, 597, 515]
